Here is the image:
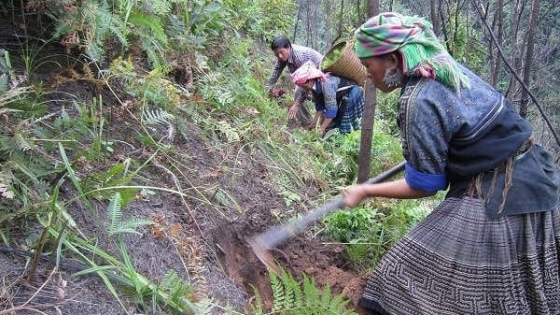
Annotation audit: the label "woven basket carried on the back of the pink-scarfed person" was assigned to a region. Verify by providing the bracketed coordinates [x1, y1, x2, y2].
[321, 41, 367, 85]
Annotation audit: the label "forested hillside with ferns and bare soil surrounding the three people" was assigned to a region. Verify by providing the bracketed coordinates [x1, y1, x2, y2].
[0, 0, 560, 314]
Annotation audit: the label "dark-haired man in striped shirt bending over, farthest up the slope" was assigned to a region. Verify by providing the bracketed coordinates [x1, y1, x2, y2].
[265, 35, 323, 126]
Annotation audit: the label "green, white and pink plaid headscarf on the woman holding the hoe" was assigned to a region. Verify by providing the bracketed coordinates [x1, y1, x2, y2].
[354, 12, 470, 91]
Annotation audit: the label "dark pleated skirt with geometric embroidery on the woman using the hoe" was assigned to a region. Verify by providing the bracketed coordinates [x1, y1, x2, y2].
[360, 197, 560, 315]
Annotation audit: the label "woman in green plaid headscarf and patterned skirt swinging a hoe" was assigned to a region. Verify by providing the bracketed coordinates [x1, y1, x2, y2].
[342, 12, 560, 315]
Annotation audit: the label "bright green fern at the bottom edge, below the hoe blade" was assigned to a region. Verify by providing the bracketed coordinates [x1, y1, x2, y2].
[253, 269, 357, 315]
